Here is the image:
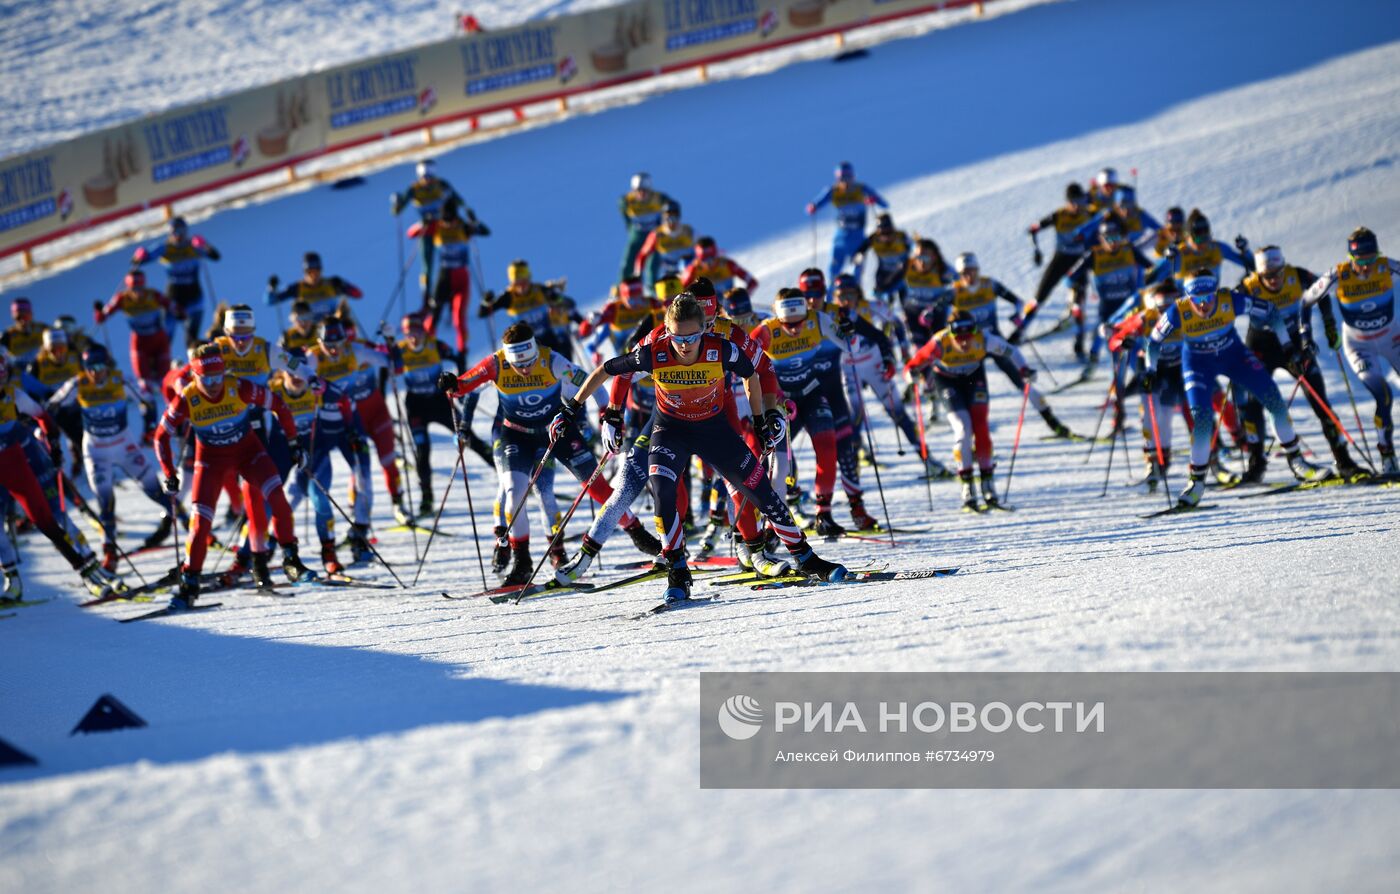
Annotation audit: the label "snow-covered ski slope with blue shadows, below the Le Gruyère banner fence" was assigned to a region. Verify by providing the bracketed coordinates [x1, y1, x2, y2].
[0, 0, 1400, 891]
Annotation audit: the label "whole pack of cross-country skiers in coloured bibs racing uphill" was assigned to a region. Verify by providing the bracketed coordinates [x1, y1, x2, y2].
[0, 161, 1400, 609]
